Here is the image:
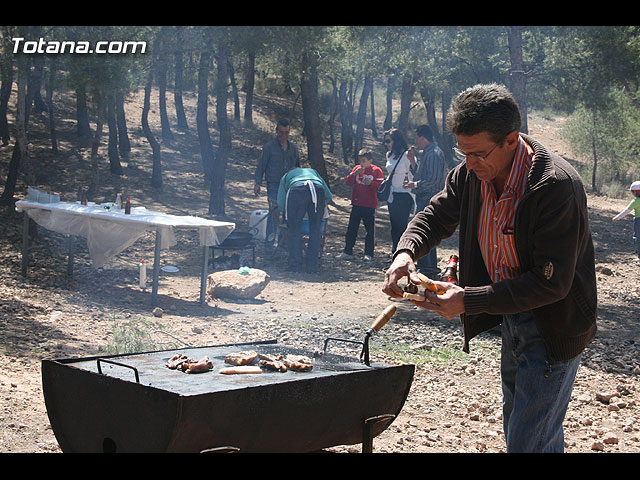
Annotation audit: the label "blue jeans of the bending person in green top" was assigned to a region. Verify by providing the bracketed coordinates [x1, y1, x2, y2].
[287, 185, 326, 273]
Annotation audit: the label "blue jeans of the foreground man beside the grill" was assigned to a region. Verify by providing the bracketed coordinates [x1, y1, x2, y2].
[501, 312, 581, 453]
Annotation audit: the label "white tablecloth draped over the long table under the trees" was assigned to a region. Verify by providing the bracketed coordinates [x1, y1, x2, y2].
[16, 200, 235, 267]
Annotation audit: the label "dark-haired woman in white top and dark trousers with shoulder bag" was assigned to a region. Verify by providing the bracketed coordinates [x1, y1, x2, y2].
[384, 128, 415, 253]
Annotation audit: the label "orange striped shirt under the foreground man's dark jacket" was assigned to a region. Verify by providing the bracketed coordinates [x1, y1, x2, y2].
[478, 138, 534, 282]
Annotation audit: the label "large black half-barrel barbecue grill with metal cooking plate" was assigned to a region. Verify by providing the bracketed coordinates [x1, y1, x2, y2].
[42, 333, 415, 452]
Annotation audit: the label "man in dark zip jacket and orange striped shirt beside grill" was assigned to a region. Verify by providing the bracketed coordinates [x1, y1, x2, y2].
[383, 84, 597, 452]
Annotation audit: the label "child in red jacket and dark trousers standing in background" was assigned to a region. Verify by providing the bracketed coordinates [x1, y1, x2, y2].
[338, 149, 384, 260]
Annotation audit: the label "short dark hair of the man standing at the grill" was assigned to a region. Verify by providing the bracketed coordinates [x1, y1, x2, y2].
[447, 83, 522, 142]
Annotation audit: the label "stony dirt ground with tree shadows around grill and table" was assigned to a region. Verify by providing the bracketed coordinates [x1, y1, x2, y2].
[0, 90, 640, 453]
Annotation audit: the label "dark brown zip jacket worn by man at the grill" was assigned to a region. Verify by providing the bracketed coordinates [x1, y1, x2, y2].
[396, 134, 597, 363]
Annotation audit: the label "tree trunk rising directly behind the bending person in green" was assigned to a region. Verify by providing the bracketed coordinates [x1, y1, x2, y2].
[300, 51, 329, 185]
